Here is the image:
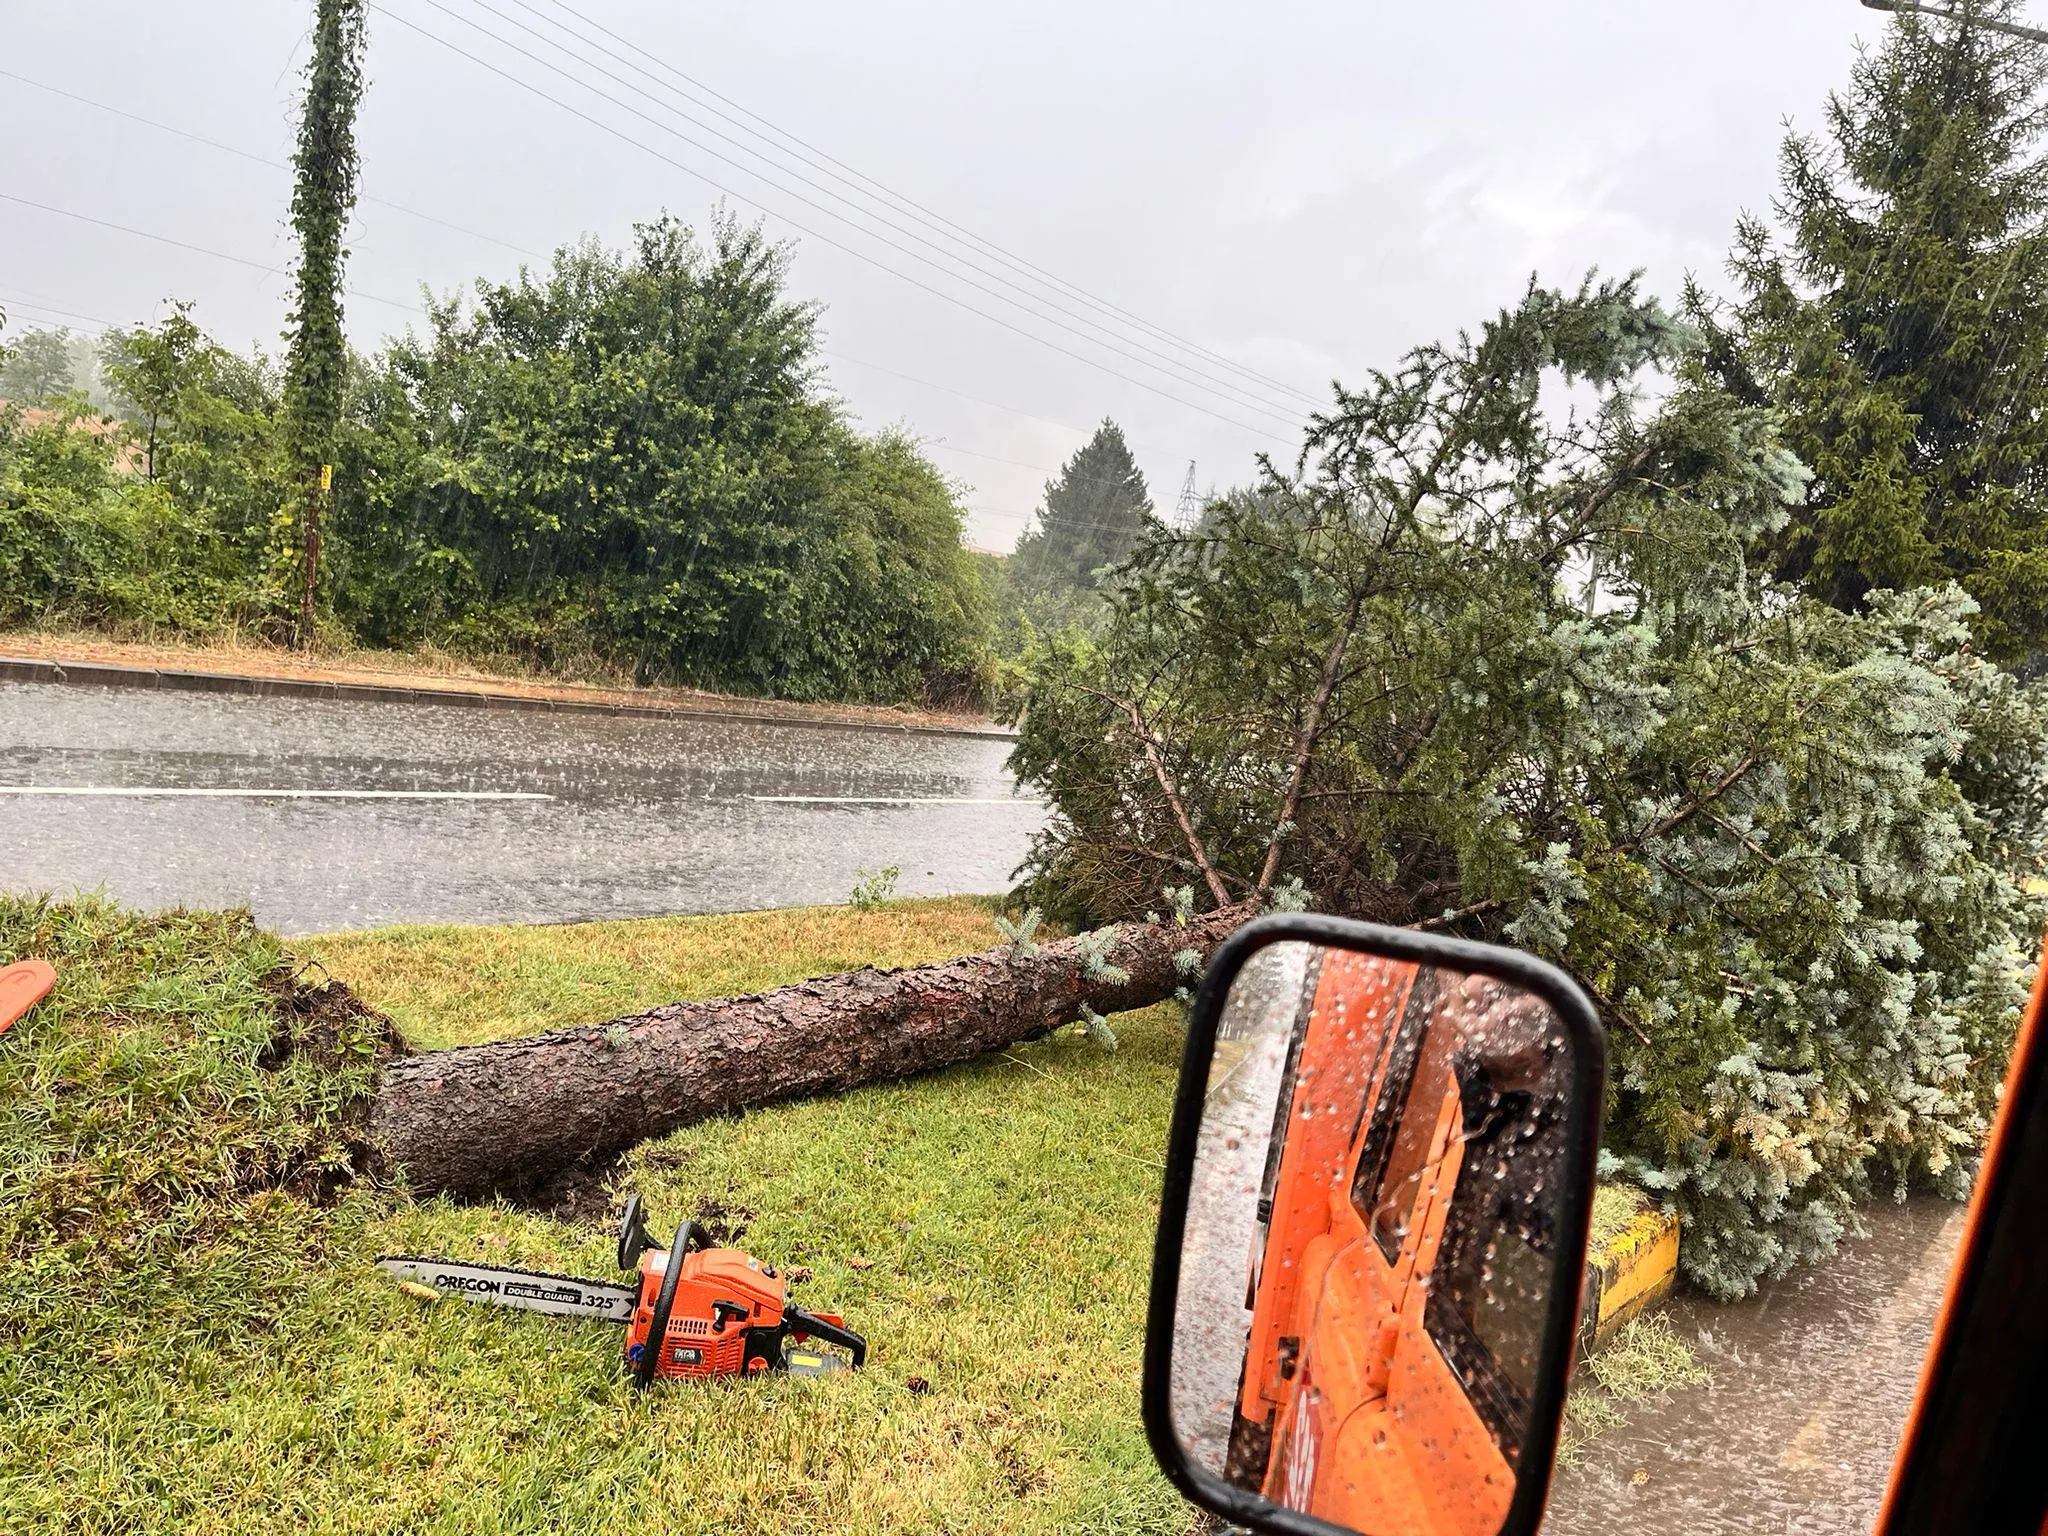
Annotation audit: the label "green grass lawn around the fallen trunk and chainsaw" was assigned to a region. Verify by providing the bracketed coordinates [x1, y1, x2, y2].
[0, 899, 1190, 1534]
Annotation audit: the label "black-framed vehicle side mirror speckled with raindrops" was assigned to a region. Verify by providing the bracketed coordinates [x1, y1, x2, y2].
[1143, 915, 1606, 1536]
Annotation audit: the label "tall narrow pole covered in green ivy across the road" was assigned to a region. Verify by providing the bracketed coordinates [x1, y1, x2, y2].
[279, 0, 362, 645]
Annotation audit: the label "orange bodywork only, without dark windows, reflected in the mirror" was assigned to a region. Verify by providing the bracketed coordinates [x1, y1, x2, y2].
[1239, 954, 1516, 1536]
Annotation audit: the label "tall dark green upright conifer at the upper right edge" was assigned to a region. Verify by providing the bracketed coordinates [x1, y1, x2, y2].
[1692, 0, 2048, 664]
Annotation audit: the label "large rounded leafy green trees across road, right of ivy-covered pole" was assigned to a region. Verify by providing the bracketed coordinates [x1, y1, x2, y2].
[336, 217, 987, 698]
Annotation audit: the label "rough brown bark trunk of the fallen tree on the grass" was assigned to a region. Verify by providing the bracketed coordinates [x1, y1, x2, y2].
[371, 907, 1251, 1194]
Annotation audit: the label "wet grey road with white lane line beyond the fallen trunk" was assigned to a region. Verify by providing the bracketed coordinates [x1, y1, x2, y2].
[0, 684, 1042, 934]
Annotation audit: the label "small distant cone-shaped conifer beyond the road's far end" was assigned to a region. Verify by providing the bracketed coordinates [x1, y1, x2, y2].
[1008, 420, 1159, 623]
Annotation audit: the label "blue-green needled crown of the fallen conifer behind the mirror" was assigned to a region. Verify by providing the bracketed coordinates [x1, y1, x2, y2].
[1014, 283, 2042, 1296]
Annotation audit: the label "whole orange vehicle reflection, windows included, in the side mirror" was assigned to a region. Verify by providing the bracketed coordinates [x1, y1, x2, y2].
[1227, 950, 1561, 1536]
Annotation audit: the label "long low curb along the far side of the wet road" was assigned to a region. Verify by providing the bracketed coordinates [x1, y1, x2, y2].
[0, 655, 1016, 741]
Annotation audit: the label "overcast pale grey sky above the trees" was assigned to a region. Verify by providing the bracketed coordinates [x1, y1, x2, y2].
[0, 0, 1908, 549]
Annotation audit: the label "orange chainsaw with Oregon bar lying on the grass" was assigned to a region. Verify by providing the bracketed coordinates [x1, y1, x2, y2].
[377, 1194, 868, 1386]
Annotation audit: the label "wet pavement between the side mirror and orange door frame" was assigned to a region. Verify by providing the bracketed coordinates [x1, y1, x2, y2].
[1544, 1198, 1964, 1536]
